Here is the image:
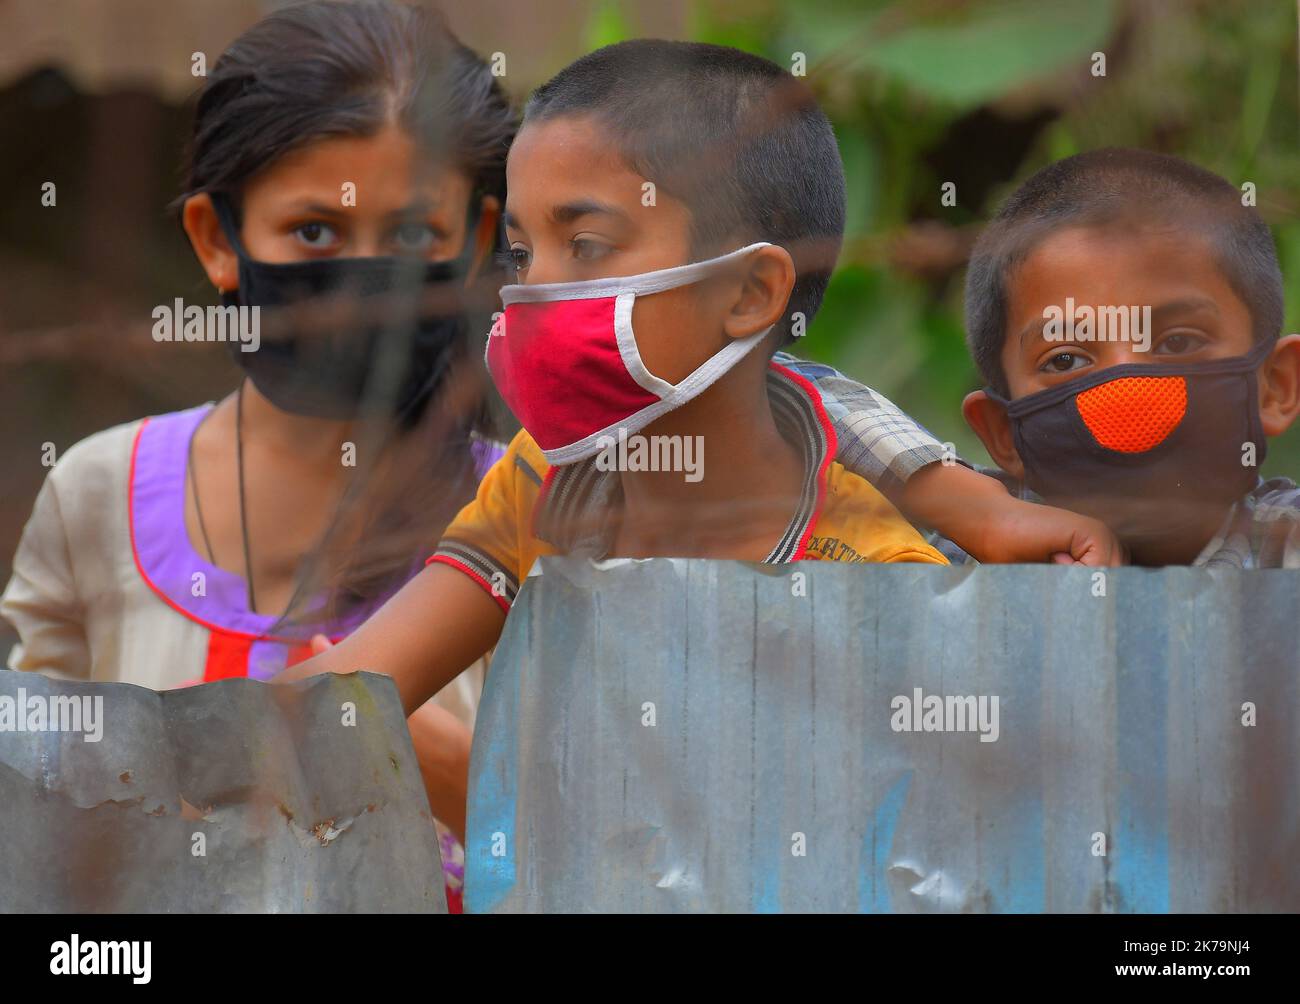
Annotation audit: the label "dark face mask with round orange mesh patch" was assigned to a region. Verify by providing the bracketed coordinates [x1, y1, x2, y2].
[985, 341, 1273, 519]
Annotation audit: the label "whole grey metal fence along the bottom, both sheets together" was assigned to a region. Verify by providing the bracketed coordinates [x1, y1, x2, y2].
[0, 559, 1300, 912]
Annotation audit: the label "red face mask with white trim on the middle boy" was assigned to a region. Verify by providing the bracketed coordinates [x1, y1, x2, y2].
[486, 242, 771, 464]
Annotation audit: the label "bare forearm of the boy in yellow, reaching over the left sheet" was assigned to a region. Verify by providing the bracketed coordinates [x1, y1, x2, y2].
[276, 564, 506, 715]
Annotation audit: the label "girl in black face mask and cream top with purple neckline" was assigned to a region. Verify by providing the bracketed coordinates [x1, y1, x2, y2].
[4, 3, 516, 905]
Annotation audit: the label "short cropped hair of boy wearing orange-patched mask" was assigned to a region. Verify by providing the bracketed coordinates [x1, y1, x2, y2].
[966, 147, 1284, 397]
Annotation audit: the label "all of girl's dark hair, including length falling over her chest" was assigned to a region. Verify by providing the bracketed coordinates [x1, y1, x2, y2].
[176, 0, 517, 636]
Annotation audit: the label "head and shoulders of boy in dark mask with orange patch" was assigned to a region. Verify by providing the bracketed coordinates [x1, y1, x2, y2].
[963, 150, 1300, 567]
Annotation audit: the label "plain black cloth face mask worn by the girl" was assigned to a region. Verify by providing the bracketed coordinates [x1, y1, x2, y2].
[212, 192, 477, 423]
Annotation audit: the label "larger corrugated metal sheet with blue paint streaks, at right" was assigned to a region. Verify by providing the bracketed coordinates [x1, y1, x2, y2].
[465, 559, 1300, 913]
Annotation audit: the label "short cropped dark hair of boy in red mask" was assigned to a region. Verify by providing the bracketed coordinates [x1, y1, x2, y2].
[524, 39, 845, 345]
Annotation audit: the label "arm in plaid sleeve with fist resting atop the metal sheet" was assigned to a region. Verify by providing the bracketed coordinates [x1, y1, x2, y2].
[777, 352, 1123, 564]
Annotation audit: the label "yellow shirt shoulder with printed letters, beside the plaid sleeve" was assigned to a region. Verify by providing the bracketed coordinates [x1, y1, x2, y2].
[805, 463, 948, 564]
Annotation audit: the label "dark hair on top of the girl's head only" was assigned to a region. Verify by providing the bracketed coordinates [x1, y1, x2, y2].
[181, 0, 517, 209]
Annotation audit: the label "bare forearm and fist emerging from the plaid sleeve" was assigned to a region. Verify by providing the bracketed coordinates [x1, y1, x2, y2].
[900, 463, 1126, 566]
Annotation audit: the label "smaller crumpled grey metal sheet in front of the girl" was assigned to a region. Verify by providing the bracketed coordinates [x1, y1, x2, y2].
[0, 670, 446, 913]
